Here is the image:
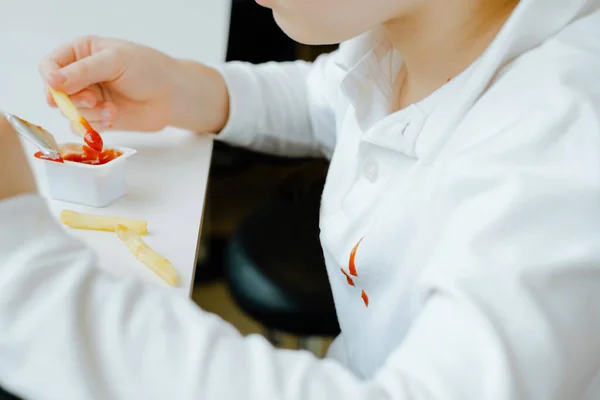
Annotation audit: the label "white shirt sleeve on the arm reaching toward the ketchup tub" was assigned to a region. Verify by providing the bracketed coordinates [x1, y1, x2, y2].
[216, 54, 339, 157]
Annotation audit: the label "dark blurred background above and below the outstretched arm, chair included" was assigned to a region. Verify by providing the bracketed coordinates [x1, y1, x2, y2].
[193, 0, 339, 355]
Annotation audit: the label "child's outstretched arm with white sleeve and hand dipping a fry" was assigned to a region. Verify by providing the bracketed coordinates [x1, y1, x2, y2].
[40, 36, 338, 155]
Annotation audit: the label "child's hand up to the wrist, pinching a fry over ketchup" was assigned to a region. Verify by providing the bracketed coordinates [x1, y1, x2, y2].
[40, 36, 175, 131]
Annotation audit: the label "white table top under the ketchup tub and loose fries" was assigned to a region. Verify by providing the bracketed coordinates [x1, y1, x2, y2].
[0, 0, 230, 296]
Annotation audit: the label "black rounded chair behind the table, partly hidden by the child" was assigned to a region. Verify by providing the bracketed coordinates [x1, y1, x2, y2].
[225, 170, 340, 347]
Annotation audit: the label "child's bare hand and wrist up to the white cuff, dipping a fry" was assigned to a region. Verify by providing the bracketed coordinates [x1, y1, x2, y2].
[40, 36, 227, 132]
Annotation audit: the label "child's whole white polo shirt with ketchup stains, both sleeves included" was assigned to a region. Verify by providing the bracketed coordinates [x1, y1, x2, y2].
[0, 0, 600, 400]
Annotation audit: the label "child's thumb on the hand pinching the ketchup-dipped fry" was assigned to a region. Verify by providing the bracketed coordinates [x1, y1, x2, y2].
[48, 48, 125, 94]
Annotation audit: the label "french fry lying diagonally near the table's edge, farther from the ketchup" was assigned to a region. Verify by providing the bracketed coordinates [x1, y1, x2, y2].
[116, 225, 178, 286]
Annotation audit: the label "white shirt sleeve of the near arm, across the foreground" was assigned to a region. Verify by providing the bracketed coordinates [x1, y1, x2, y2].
[0, 115, 600, 400]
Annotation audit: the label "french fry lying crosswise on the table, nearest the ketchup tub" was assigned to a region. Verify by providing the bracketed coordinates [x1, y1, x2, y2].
[60, 210, 148, 235]
